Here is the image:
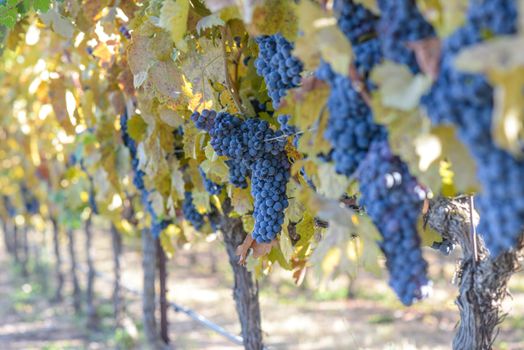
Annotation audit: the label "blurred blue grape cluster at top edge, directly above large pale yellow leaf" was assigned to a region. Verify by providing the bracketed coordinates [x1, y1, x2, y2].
[378, 0, 435, 73]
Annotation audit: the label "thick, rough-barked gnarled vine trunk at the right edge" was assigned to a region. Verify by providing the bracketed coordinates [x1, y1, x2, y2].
[426, 197, 524, 350]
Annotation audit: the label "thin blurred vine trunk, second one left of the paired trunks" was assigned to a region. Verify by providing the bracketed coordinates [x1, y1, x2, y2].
[84, 214, 98, 329]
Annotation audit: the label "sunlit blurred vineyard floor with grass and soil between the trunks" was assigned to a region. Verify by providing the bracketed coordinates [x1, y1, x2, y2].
[0, 221, 524, 350]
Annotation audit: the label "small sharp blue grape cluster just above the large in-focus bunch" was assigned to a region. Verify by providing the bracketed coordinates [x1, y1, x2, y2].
[255, 34, 304, 109]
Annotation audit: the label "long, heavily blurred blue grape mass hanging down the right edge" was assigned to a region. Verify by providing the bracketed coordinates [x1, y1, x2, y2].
[422, 0, 524, 256]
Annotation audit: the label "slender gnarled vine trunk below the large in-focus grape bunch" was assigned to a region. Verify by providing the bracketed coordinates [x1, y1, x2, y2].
[220, 205, 264, 350]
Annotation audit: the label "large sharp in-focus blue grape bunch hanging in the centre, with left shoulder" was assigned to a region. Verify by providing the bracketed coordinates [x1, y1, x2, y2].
[191, 110, 290, 242]
